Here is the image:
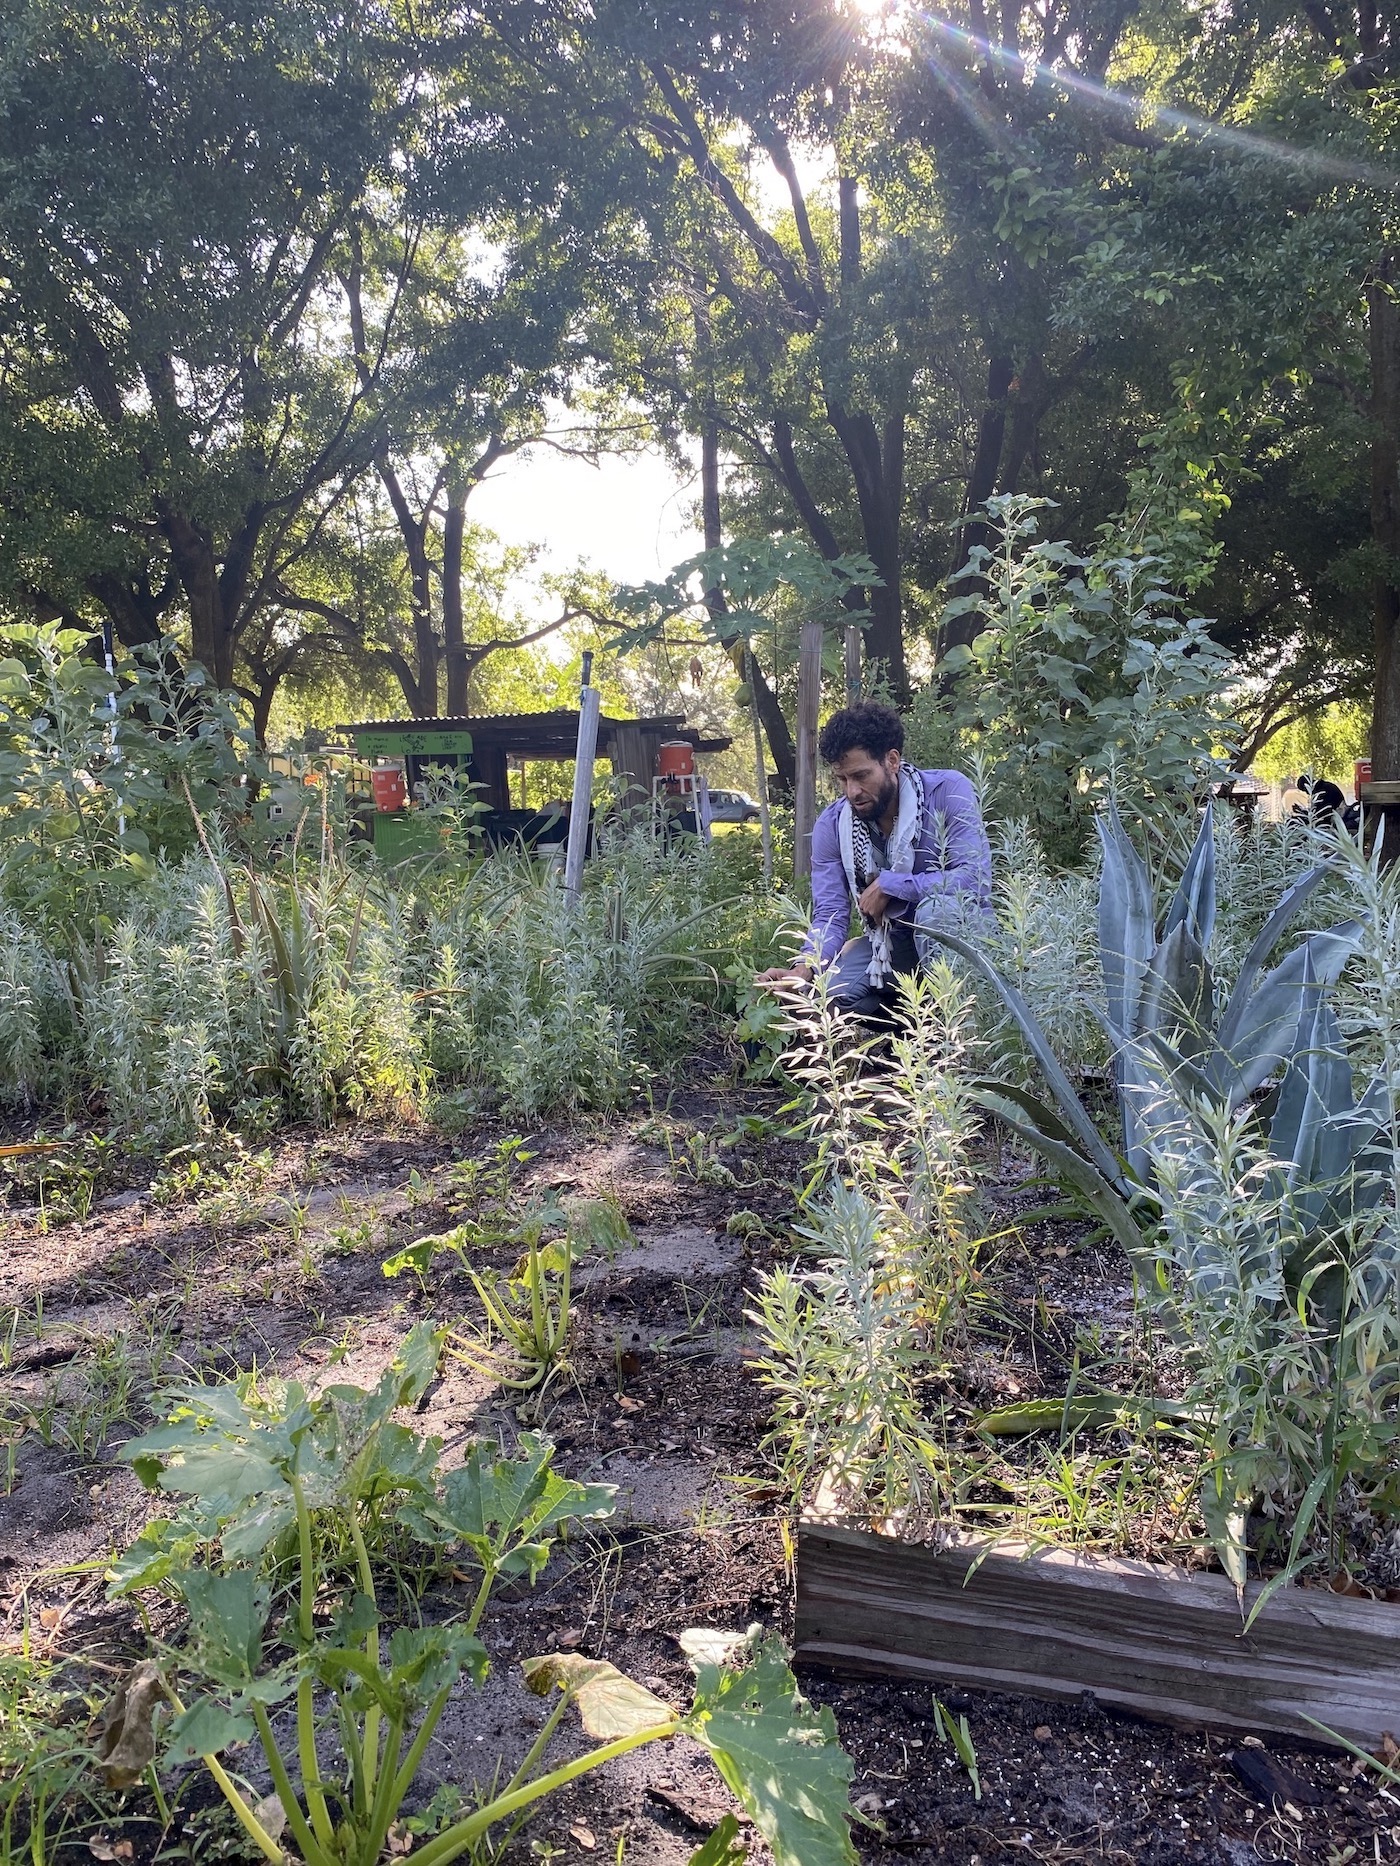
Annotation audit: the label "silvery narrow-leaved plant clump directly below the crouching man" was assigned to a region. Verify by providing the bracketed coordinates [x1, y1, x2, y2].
[750, 965, 980, 1523]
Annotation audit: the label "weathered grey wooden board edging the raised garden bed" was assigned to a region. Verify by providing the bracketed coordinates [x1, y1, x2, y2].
[797, 1521, 1400, 1748]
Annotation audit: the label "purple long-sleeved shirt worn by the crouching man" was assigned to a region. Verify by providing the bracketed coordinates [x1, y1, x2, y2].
[806, 765, 991, 965]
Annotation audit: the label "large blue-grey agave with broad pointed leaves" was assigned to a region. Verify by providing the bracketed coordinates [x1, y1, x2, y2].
[930, 808, 1381, 1288]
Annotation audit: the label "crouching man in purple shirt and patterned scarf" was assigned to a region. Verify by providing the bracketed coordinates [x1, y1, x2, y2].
[760, 700, 991, 1019]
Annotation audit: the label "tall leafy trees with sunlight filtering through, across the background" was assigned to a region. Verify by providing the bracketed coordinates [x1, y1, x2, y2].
[0, 0, 1400, 776]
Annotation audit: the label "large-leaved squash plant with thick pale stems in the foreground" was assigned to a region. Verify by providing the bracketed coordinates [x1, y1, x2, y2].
[103, 1325, 855, 1866]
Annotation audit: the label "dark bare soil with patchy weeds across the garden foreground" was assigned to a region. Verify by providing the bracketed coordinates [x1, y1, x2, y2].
[0, 1092, 1400, 1866]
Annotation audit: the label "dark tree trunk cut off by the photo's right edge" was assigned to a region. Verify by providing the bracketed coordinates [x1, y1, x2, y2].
[1366, 254, 1400, 784]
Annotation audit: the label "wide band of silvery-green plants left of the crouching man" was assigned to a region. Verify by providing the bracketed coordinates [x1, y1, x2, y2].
[0, 825, 778, 1148]
